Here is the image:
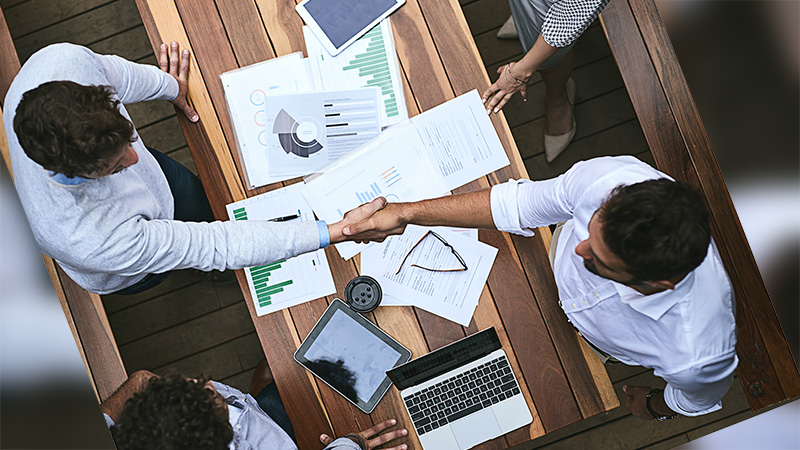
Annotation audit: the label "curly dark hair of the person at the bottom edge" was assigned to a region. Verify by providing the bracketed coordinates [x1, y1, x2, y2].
[111, 375, 233, 450]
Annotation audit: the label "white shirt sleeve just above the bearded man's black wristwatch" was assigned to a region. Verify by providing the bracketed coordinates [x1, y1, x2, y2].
[656, 352, 739, 416]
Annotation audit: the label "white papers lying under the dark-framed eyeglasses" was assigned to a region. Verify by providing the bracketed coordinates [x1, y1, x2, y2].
[361, 225, 497, 326]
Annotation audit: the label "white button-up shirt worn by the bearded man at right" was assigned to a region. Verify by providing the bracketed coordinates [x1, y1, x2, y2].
[491, 156, 738, 416]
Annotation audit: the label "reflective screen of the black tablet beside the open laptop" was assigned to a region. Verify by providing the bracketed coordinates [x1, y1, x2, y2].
[304, 310, 400, 403]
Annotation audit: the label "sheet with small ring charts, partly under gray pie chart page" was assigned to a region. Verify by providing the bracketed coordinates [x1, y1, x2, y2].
[219, 52, 314, 189]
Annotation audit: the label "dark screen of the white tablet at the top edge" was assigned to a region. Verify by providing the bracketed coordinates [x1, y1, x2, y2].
[303, 0, 397, 48]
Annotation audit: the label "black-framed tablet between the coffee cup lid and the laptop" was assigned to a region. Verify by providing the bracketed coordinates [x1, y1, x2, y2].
[294, 299, 411, 413]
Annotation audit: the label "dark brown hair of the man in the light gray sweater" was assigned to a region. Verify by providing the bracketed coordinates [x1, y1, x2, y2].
[14, 81, 135, 177]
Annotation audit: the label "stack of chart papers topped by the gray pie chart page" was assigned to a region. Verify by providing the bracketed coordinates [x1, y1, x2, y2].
[220, 19, 408, 189]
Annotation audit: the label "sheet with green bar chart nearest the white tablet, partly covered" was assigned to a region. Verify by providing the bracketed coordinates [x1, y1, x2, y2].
[303, 18, 408, 127]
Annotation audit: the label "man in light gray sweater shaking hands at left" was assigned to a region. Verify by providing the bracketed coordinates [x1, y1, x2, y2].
[4, 42, 383, 294]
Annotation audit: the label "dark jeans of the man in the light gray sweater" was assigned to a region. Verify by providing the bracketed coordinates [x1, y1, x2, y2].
[114, 147, 214, 295]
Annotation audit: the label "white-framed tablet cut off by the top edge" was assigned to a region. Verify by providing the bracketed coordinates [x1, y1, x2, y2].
[297, 0, 406, 56]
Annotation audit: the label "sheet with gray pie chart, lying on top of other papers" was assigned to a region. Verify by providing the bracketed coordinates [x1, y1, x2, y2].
[264, 88, 381, 178]
